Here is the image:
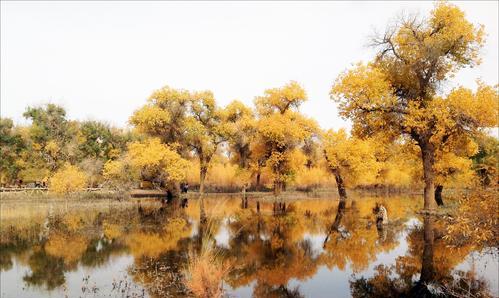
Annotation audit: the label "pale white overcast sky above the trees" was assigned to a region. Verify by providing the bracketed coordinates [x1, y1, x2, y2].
[0, 1, 499, 129]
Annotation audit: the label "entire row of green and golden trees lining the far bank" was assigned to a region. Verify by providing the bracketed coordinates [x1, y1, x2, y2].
[0, 3, 498, 209]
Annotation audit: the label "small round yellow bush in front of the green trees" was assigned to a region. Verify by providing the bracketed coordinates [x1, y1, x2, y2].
[49, 164, 87, 194]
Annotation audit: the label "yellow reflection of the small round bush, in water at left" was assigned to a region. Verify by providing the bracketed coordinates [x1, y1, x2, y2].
[45, 234, 87, 265]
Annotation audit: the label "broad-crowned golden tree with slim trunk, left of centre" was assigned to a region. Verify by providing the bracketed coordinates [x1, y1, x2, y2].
[130, 86, 226, 194]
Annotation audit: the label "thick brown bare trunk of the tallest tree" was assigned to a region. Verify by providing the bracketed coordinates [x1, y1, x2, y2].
[419, 141, 435, 211]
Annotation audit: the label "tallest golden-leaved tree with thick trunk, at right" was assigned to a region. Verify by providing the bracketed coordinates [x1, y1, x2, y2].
[331, 2, 498, 210]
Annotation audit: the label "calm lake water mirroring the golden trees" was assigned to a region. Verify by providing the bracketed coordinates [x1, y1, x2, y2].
[0, 196, 499, 298]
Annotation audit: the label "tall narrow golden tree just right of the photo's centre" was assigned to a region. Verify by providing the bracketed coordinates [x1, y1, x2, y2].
[255, 82, 317, 195]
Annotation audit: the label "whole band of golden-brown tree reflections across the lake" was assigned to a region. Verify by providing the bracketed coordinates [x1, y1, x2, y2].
[0, 198, 496, 297]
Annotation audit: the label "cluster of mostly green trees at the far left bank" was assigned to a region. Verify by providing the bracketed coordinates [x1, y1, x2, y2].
[0, 104, 136, 185]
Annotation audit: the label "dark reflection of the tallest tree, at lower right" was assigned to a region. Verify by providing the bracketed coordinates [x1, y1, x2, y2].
[350, 215, 490, 297]
